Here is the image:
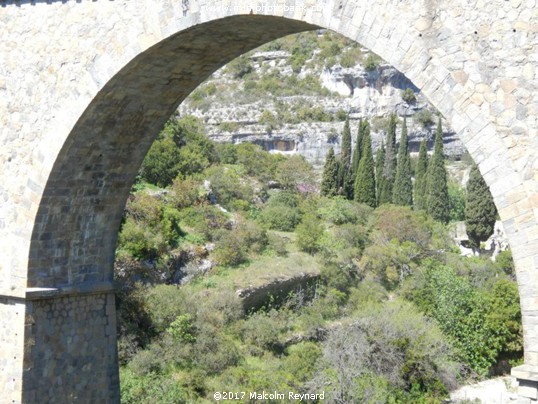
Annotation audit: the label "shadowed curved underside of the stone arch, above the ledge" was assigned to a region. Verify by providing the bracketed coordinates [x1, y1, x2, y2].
[28, 15, 317, 288]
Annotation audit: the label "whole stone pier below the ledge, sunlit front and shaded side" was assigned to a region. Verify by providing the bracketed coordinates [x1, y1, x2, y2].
[0, 283, 120, 403]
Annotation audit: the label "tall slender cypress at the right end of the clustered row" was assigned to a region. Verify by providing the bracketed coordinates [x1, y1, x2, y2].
[426, 117, 450, 223]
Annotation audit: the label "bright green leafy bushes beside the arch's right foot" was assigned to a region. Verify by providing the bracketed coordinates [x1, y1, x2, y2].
[406, 261, 522, 375]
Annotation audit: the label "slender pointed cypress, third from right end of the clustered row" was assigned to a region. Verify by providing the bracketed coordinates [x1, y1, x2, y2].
[392, 118, 413, 206]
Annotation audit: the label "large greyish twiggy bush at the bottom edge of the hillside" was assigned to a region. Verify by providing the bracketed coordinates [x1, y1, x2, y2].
[311, 301, 458, 403]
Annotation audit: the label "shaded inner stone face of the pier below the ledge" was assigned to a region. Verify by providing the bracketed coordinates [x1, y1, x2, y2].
[22, 293, 119, 403]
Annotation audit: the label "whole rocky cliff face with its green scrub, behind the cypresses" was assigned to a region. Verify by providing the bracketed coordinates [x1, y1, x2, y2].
[179, 32, 465, 166]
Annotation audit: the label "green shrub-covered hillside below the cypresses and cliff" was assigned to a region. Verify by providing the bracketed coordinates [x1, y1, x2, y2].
[115, 116, 522, 403]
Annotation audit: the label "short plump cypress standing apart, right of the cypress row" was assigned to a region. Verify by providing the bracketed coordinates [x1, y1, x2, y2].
[465, 164, 497, 249]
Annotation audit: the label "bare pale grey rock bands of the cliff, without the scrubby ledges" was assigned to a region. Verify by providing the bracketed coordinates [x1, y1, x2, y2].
[179, 51, 465, 168]
